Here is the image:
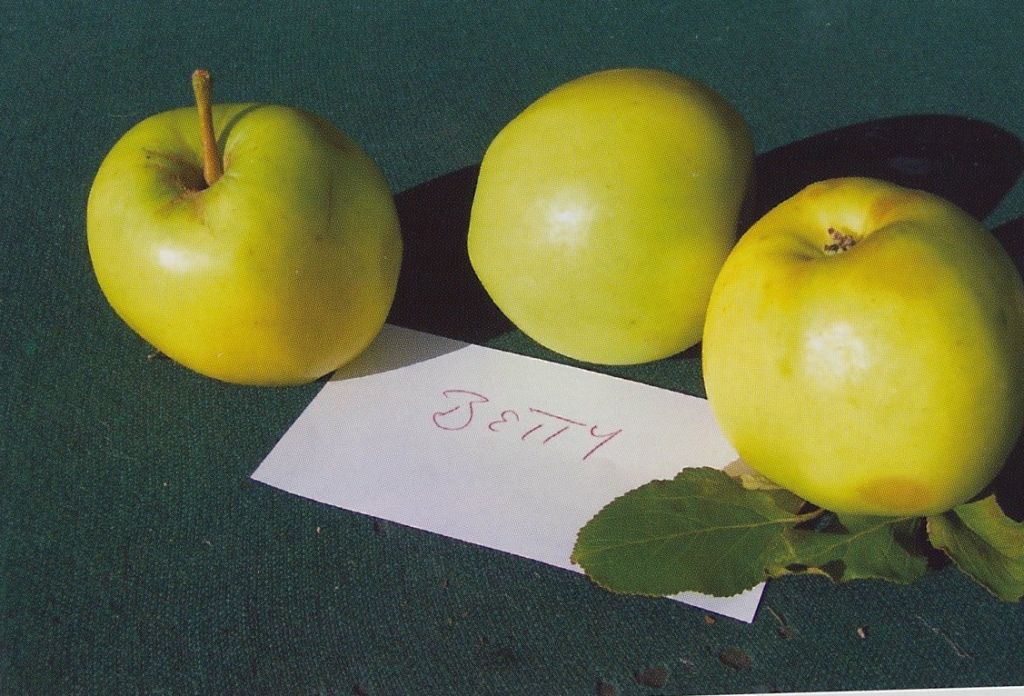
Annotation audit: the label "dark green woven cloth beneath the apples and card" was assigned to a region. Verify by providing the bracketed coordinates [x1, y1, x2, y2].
[6, 0, 1024, 696]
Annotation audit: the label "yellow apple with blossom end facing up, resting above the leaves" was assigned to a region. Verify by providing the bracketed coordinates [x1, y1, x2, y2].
[701, 178, 1024, 516]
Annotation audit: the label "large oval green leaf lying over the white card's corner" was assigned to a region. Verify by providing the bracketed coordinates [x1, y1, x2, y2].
[572, 468, 818, 597]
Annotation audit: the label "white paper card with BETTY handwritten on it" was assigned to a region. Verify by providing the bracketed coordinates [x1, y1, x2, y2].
[252, 324, 763, 621]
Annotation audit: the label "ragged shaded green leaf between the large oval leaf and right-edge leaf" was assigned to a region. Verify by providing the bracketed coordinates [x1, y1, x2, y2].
[771, 515, 928, 584]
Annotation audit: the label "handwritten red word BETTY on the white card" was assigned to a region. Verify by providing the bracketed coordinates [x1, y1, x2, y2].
[432, 389, 623, 460]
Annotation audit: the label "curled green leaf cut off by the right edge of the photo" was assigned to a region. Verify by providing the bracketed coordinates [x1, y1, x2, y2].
[928, 494, 1024, 602]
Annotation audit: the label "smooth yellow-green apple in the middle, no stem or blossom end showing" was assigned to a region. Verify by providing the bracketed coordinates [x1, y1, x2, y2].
[468, 69, 754, 364]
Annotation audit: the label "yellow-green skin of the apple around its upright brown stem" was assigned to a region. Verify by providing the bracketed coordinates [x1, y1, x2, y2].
[87, 104, 401, 385]
